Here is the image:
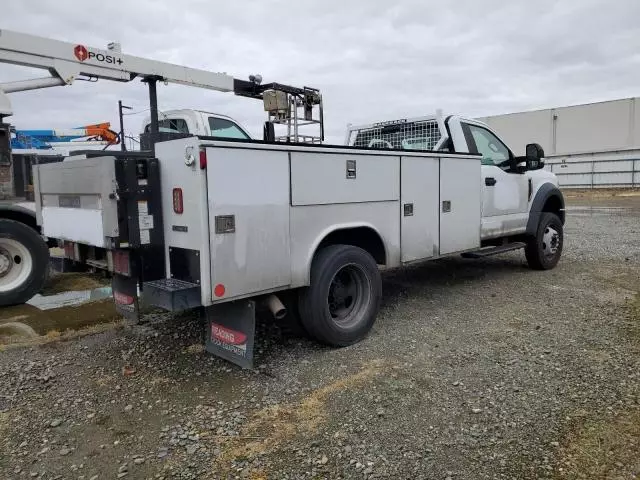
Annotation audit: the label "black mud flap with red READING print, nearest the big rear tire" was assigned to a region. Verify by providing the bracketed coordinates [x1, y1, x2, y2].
[204, 300, 256, 369]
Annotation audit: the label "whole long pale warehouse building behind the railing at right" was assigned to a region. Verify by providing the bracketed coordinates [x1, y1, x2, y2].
[479, 97, 640, 187]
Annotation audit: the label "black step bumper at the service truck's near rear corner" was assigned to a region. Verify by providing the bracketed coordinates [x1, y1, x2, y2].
[142, 278, 202, 312]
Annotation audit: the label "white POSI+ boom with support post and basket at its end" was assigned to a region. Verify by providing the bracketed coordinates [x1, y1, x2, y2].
[0, 29, 324, 142]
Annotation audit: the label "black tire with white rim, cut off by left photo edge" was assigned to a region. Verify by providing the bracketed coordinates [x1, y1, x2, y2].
[0, 219, 49, 306]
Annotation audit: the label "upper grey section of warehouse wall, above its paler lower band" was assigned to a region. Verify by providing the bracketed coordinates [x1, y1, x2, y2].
[479, 97, 640, 156]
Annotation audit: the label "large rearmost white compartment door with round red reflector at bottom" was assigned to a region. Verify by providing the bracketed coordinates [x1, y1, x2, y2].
[206, 146, 291, 302]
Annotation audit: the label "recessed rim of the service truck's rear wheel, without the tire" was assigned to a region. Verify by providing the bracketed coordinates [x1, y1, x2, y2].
[327, 264, 371, 328]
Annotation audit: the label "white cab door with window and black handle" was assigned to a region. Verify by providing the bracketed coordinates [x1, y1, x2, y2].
[462, 123, 529, 238]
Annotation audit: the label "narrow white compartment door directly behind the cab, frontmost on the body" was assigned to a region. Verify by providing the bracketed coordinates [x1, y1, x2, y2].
[440, 157, 482, 255]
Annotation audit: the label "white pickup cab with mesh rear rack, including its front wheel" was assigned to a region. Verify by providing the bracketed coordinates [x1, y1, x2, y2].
[346, 114, 565, 269]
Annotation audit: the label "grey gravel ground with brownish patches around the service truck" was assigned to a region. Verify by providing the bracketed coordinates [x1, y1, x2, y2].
[0, 198, 640, 480]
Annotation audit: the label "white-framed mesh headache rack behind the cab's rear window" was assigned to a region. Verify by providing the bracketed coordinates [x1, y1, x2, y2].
[345, 112, 448, 152]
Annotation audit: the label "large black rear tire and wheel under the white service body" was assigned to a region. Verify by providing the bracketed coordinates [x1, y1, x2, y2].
[300, 245, 382, 347]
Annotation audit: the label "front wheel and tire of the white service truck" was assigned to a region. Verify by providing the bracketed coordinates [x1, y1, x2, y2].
[524, 212, 564, 270]
